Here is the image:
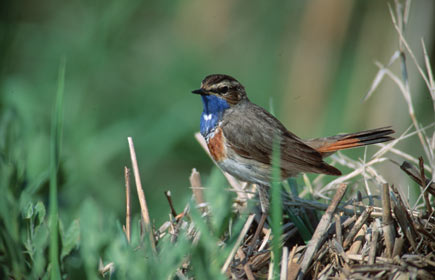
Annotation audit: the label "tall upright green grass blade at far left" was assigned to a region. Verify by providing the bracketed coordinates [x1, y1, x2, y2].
[50, 58, 66, 279]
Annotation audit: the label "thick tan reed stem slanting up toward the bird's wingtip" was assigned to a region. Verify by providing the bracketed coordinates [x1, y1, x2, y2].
[298, 184, 347, 279]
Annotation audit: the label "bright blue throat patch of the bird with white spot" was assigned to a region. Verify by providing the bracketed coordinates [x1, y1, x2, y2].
[200, 95, 230, 137]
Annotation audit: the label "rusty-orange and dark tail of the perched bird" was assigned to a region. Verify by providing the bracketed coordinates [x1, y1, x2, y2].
[305, 126, 394, 157]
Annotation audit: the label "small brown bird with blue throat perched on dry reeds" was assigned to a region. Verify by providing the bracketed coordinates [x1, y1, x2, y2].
[192, 74, 394, 248]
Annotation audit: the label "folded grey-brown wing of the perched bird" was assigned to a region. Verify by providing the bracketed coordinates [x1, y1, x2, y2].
[222, 102, 341, 177]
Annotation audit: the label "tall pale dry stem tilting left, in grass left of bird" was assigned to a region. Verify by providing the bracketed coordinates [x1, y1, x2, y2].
[127, 137, 156, 252]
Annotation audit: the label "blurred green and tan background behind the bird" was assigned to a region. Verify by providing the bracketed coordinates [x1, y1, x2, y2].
[0, 0, 435, 230]
